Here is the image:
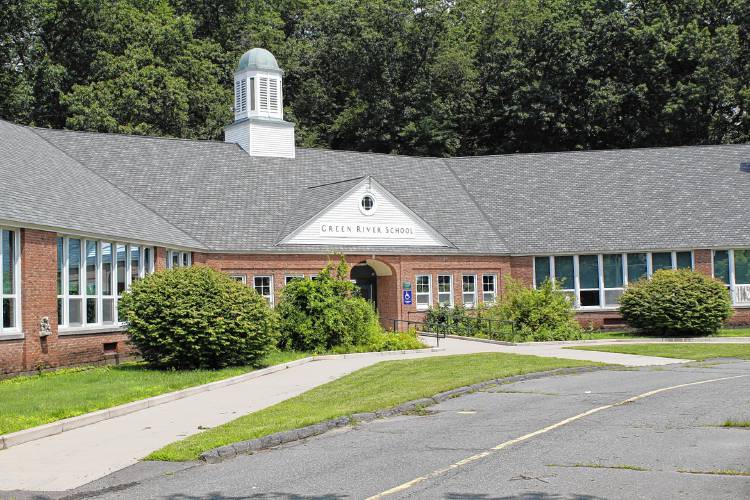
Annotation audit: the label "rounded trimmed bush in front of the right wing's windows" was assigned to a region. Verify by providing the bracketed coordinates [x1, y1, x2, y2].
[620, 269, 732, 335]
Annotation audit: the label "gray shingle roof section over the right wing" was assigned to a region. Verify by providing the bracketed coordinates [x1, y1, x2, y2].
[446, 145, 750, 254]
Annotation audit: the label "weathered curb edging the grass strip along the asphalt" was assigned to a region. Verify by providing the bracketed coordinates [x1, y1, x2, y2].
[199, 366, 608, 464]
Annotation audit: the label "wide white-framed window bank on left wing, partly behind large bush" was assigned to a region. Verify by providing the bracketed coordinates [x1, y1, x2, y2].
[57, 236, 154, 329]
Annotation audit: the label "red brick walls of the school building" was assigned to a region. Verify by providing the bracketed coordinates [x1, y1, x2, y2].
[0, 241, 750, 374]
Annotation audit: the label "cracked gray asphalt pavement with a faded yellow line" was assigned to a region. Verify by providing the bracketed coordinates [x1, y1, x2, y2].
[10, 360, 750, 500]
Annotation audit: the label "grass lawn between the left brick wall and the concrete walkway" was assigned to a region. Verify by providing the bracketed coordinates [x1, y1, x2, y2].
[0, 352, 309, 434]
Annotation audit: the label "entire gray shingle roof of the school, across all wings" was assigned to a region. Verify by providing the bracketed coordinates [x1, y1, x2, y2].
[5, 121, 750, 255]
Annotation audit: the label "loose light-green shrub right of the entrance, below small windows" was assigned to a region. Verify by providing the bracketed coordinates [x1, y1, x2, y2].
[484, 277, 583, 342]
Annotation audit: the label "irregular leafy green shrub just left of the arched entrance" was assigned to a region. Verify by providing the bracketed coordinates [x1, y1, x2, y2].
[276, 258, 382, 353]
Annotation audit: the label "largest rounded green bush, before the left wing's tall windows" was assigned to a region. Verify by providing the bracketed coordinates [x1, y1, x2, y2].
[119, 266, 277, 369]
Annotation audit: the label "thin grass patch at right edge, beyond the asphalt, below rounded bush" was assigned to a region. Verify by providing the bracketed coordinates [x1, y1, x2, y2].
[566, 343, 750, 361]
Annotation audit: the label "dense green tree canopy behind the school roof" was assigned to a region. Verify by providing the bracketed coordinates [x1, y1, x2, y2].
[0, 0, 750, 156]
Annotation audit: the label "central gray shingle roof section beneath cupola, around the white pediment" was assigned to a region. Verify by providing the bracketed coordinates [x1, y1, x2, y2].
[35, 129, 508, 254]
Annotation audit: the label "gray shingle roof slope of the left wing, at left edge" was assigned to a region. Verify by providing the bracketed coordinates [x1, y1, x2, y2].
[0, 120, 203, 248]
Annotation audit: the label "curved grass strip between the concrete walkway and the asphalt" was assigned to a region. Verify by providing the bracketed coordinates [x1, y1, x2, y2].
[147, 353, 597, 461]
